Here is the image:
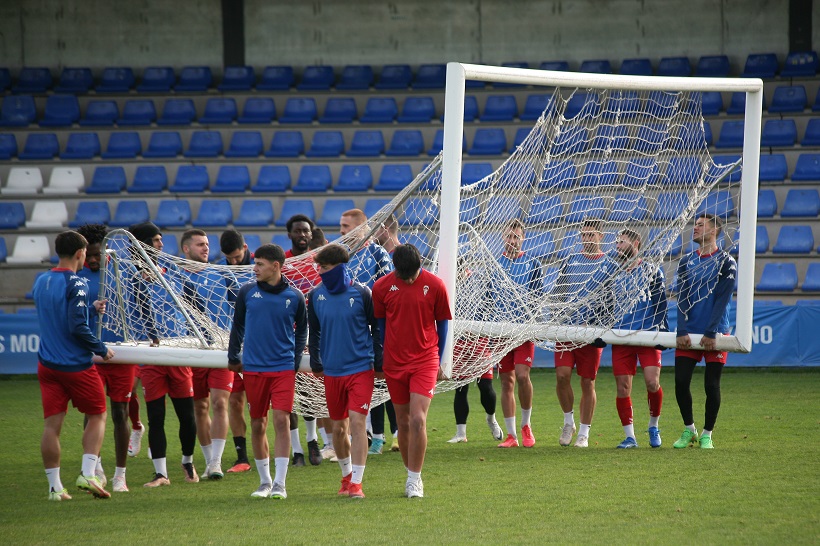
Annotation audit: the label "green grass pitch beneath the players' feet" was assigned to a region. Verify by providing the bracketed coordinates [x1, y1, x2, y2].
[0, 369, 820, 544]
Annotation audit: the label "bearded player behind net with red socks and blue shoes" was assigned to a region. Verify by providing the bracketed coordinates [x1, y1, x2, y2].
[612, 229, 669, 449]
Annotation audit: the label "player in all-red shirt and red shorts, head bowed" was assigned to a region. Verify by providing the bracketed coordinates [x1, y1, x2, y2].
[373, 244, 453, 498]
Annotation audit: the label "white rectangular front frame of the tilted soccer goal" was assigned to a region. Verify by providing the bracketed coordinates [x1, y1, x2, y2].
[438, 62, 763, 371]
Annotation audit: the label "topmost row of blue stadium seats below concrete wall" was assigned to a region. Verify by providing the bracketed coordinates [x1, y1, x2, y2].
[0, 51, 818, 93]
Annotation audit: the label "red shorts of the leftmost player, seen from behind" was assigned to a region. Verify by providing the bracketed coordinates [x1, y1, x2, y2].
[37, 362, 105, 419]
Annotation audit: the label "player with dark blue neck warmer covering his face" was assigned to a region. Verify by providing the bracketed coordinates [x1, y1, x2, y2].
[307, 244, 382, 498]
